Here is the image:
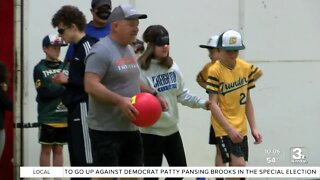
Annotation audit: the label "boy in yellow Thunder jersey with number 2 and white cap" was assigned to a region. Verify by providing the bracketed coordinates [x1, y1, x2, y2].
[207, 30, 262, 176]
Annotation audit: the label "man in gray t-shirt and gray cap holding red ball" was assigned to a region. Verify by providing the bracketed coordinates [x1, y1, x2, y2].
[85, 4, 166, 169]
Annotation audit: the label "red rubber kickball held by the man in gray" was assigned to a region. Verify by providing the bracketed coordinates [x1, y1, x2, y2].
[131, 93, 162, 127]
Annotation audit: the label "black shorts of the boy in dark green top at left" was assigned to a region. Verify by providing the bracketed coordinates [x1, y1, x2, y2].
[39, 124, 68, 145]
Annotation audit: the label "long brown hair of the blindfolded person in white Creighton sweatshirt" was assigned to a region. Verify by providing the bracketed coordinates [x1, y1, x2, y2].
[138, 25, 173, 70]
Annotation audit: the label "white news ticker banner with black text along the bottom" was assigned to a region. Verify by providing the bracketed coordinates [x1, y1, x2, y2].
[20, 167, 320, 178]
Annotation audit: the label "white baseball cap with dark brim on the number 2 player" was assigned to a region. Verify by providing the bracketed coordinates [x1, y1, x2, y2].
[218, 30, 245, 51]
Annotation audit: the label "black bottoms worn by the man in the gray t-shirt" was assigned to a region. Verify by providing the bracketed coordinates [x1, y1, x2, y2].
[89, 129, 143, 166]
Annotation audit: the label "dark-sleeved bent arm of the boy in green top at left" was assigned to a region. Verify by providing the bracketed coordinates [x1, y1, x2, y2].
[33, 68, 65, 98]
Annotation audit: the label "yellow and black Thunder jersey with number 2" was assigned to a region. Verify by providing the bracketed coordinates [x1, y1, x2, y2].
[206, 58, 261, 136]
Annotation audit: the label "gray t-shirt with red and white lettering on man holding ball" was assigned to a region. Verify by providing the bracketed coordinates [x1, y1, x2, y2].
[86, 36, 140, 131]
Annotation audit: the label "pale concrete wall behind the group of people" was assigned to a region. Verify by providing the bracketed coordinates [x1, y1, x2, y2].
[24, 0, 320, 173]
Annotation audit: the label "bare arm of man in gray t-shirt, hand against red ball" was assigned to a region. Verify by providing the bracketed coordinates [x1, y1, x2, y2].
[84, 72, 139, 120]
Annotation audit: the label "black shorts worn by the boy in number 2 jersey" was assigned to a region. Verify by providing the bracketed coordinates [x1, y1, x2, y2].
[216, 136, 249, 163]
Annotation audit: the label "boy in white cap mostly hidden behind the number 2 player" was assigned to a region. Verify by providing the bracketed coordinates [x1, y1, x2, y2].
[197, 35, 224, 173]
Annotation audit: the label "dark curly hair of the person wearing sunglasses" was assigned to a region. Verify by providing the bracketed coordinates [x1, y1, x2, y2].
[51, 5, 86, 31]
